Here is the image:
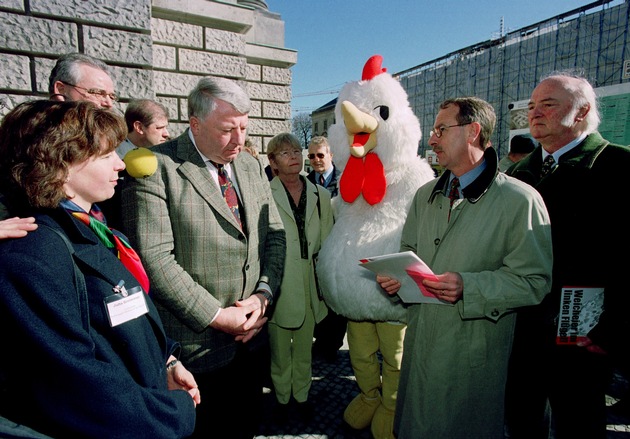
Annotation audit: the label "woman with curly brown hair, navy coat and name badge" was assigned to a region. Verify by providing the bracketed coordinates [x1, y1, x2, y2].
[0, 100, 200, 438]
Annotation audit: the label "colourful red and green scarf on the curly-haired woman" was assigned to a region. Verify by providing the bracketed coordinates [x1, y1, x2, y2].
[70, 210, 149, 294]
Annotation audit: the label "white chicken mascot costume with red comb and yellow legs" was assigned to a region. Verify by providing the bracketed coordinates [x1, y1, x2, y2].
[317, 55, 434, 439]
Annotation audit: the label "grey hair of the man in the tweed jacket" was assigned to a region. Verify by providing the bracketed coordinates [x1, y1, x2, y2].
[188, 76, 252, 119]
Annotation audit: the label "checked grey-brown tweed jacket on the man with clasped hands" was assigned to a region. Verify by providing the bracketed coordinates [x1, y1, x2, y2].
[122, 130, 286, 372]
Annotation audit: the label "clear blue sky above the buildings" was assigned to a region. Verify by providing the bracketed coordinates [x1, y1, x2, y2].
[266, 0, 623, 115]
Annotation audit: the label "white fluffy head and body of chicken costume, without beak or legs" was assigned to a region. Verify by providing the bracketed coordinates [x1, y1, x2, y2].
[317, 73, 434, 322]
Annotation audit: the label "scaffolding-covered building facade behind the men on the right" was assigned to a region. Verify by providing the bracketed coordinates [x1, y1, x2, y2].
[394, 0, 630, 157]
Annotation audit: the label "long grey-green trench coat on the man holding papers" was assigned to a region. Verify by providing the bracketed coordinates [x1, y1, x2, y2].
[395, 149, 552, 439]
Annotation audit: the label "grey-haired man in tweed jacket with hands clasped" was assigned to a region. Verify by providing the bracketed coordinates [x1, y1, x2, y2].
[122, 77, 286, 439]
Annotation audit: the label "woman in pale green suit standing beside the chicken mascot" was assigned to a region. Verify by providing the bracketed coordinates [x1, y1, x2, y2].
[267, 133, 333, 421]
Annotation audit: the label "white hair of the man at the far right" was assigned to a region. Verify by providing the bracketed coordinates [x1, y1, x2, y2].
[539, 70, 601, 133]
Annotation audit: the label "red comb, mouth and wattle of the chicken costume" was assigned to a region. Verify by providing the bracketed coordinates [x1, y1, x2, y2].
[339, 55, 387, 205]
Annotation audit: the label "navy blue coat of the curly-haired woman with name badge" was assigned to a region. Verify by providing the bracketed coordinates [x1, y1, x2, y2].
[0, 209, 195, 439]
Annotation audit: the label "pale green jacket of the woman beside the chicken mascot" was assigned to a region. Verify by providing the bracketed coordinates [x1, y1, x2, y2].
[271, 177, 333, 328]
